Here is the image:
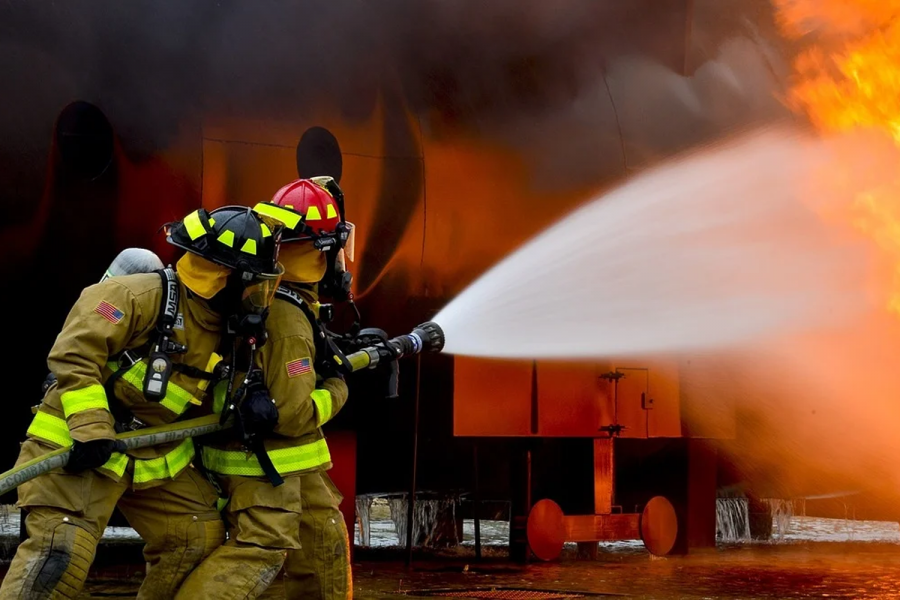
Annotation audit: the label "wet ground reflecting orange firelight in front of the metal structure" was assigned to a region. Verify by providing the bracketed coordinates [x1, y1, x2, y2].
[28, 543, 900, 600]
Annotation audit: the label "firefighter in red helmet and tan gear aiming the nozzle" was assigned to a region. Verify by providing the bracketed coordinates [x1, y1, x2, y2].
[181, 178, 351, 600]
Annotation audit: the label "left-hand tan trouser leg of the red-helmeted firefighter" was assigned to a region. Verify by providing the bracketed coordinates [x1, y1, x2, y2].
[177, 475, 302, 600]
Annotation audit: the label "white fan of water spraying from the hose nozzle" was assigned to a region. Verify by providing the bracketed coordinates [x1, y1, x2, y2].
[434, 122, 896, 358]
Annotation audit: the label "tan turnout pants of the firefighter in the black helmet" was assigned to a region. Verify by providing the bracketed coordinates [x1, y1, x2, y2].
[0, 438, 225, 600]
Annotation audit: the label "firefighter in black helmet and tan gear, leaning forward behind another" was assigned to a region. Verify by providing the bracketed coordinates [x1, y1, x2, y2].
[0, 207, 280, 598]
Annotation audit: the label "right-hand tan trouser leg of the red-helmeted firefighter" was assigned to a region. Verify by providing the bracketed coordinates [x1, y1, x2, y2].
[284, 471, 353, 600]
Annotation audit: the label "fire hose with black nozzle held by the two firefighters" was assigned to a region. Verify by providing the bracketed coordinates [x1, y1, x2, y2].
[0, 322, 444, 495]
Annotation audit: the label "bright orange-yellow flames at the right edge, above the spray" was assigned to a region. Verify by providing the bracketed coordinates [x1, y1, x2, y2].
[773, 0, 900, 314]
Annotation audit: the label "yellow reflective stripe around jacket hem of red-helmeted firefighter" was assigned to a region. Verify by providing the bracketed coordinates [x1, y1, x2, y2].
[203, 439, 331, 477]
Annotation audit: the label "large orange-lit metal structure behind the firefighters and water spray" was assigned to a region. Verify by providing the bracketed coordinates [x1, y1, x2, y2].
[0, 0, 836, 559]
